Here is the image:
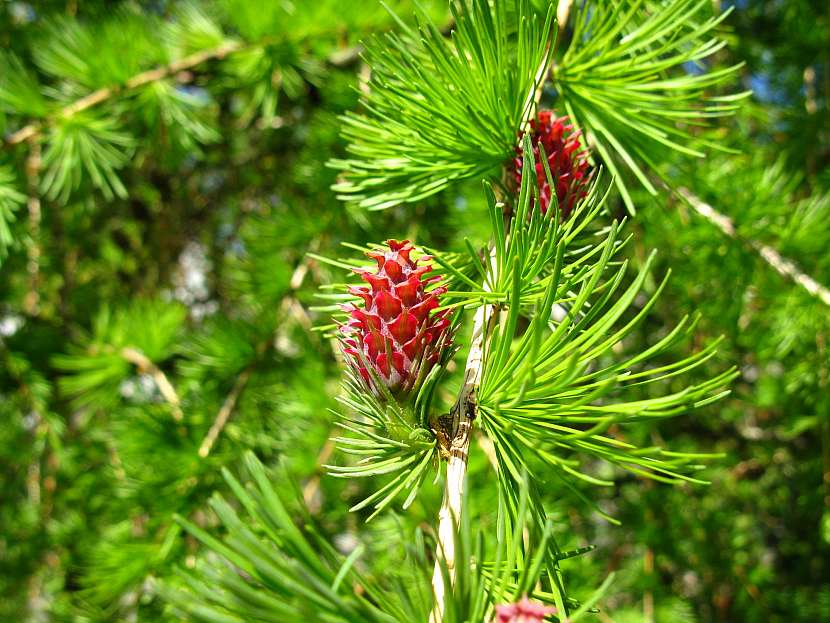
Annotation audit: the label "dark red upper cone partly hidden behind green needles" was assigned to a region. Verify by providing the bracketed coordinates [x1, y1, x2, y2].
[513, 110, 591, 218]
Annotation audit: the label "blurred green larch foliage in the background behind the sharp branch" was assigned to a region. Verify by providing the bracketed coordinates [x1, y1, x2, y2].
[0, 0, 830, 623]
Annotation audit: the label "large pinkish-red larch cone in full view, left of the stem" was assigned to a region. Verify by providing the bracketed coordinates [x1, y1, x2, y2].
[340, 240, 452, 397]
